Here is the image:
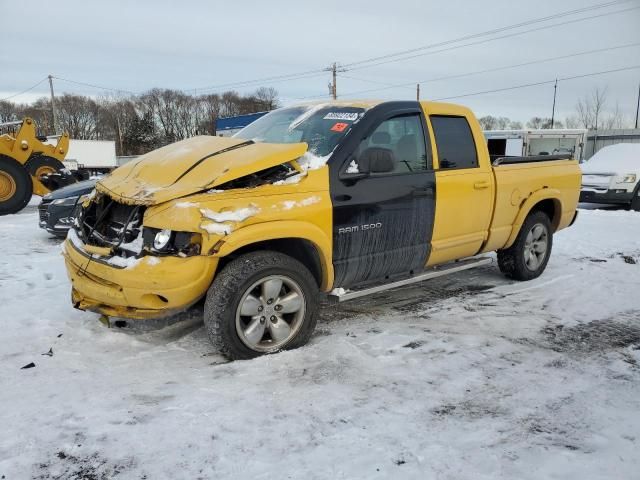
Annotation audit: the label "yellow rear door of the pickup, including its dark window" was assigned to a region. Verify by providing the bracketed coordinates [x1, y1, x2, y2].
[429, 115, 494, 265]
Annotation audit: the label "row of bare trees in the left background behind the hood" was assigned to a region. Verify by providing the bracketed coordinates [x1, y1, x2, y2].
[0, 88, 279, 155]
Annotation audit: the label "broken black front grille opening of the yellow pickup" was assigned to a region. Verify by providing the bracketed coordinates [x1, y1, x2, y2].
[78, 195, 145, 253]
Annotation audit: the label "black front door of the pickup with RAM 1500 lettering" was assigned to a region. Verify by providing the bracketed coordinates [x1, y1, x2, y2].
[330, 102, 435, 287]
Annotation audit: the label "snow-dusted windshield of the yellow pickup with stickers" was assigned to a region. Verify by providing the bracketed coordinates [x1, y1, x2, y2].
[234, 104, 364, 157]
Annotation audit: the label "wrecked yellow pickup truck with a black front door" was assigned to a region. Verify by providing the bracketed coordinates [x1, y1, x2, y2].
[63, 101, 580, 359]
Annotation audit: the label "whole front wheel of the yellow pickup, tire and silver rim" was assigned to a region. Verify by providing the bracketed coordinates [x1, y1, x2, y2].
[204, 251, 318, 360]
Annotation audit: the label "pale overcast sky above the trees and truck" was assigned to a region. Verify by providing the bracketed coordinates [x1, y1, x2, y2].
[0, 0, 640, 121]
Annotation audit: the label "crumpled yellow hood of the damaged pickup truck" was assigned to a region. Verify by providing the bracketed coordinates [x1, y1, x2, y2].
[96, 136, 308, 205]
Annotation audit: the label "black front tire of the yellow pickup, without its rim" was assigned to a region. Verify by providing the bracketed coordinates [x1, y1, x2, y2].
[204, 251, 319, 360]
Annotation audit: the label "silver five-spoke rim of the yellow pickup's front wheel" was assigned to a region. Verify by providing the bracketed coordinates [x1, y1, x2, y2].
[236, 275, 306, 352]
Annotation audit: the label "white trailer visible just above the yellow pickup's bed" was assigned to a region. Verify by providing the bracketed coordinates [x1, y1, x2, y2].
[484, 129, 587, 160]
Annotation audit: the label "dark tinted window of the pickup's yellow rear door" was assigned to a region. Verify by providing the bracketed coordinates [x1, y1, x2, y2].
[429, 115, 478, 170]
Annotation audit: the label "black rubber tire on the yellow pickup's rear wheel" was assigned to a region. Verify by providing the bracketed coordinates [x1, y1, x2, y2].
[498, 210, 553, 280]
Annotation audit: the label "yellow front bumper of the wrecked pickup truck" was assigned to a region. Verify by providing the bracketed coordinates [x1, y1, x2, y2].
[63, 240, 218, 319]
